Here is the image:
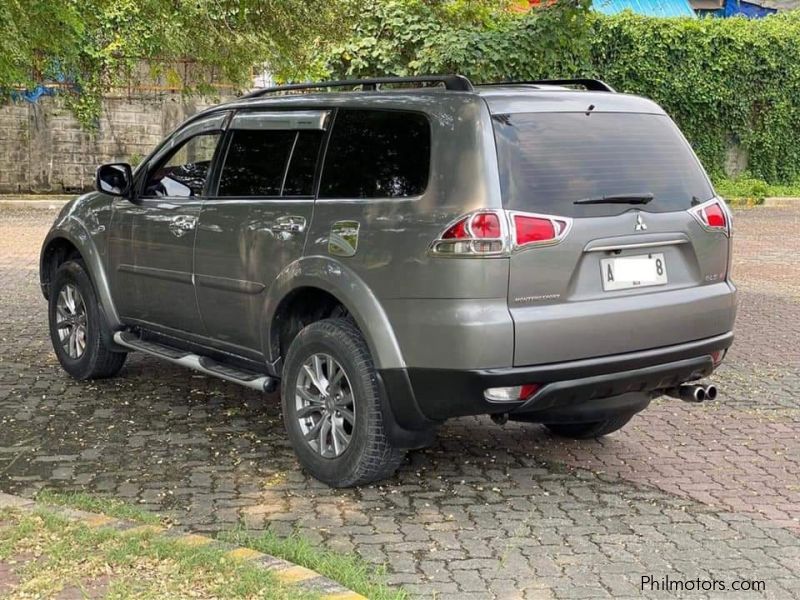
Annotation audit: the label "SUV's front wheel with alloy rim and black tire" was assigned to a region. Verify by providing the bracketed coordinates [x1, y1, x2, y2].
[48, 260, 127, 380]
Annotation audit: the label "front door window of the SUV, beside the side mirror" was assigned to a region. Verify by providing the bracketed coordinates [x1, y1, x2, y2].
[144, 132, 220, 198]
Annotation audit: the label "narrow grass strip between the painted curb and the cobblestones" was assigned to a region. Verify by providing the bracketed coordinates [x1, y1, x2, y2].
[219, 530, 409, 600]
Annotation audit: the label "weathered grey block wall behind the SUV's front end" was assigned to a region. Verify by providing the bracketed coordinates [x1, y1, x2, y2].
[0, 93, 231, 193]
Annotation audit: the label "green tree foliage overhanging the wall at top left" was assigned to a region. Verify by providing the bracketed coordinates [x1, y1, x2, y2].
[0, 0, 356, 122]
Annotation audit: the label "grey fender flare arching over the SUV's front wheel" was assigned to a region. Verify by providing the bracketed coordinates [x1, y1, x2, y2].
[39, 216, 122, 331]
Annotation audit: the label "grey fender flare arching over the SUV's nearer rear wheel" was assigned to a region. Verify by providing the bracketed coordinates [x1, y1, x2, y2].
[261, 256, 406, 369]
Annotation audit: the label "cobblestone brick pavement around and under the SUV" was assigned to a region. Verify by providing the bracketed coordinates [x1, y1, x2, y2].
[0, 204, 800, 600]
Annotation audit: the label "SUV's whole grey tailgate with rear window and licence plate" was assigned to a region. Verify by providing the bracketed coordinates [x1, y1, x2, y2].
[493, 111, 734, 365]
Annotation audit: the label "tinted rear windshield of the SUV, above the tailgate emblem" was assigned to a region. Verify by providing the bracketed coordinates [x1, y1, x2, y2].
[493, 113, 713, 217]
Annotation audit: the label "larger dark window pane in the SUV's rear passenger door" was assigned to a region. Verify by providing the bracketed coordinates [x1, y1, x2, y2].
[218, 129, 297, 196]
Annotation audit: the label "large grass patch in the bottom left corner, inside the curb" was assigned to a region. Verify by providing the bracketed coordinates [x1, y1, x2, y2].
[0, 509, 317, 600]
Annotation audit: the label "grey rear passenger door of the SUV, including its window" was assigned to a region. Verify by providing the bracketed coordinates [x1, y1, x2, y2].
[195, 110, 329, 357]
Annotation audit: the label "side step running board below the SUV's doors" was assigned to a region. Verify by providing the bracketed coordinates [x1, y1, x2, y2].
[114, 331, 278, 392]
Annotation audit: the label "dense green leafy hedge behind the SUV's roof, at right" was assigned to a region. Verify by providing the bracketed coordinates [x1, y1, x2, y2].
[330, 0, 800, 183]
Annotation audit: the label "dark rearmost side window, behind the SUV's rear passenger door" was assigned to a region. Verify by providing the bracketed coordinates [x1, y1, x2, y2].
[319, 110, 431, 198]
